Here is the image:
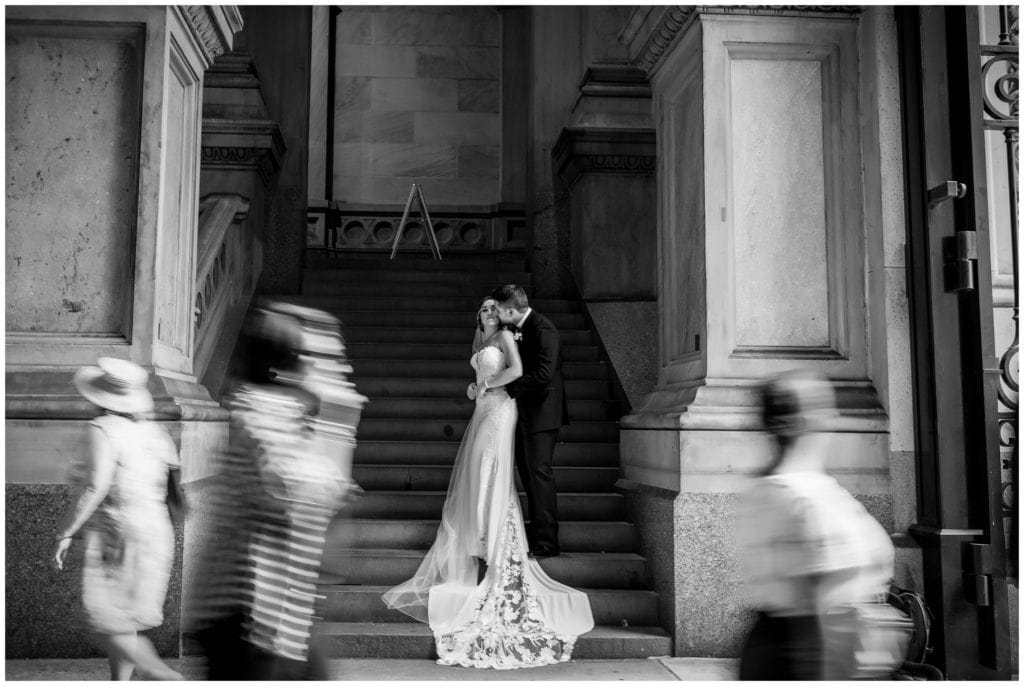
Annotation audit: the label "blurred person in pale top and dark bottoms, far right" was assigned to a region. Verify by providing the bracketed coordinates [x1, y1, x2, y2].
[736, 372, 894, 680]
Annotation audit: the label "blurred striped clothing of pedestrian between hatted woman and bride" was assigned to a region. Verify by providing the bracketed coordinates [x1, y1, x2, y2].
[185, 386, 346, 661]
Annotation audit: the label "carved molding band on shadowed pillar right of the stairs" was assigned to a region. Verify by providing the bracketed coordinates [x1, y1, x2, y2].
[551, 127, 657, 186]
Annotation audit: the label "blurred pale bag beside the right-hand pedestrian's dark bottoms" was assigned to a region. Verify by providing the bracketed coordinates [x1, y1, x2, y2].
[821, 598, 914, 681]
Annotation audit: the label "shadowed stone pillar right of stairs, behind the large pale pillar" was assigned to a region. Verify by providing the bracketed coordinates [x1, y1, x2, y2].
[552, 63, 657, 404]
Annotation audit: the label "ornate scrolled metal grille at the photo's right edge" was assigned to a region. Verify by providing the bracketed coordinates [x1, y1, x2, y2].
[981, 5, 1020, 574]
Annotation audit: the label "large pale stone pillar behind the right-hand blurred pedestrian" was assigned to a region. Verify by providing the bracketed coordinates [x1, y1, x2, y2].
[622, 7, 893, 655]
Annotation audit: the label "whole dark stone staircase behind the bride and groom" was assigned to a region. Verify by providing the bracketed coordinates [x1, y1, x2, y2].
[284, 253, 672, 658]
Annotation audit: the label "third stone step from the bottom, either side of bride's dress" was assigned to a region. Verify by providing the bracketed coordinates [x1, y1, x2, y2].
[322, 548, 646, 590]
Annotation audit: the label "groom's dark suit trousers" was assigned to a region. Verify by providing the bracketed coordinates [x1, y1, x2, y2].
[515, 423, 558, 551]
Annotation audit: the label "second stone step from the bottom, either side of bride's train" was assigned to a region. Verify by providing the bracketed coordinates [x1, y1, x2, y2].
[319, 584, 657, 627]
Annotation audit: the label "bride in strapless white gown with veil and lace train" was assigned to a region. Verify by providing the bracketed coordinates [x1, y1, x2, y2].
[384, 298, 594, 670]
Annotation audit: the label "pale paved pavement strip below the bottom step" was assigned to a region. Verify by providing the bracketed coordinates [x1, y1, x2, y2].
[4, 657, 737, 681]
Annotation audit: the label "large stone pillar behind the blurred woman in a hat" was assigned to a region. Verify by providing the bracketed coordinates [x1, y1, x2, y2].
[5, 6, 241, 657]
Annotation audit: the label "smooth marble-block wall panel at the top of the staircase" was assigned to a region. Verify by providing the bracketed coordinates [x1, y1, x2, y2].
[333, 6, 501, 205]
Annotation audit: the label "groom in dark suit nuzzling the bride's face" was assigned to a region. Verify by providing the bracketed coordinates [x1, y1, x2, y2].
[490, 284, 568, 557]
